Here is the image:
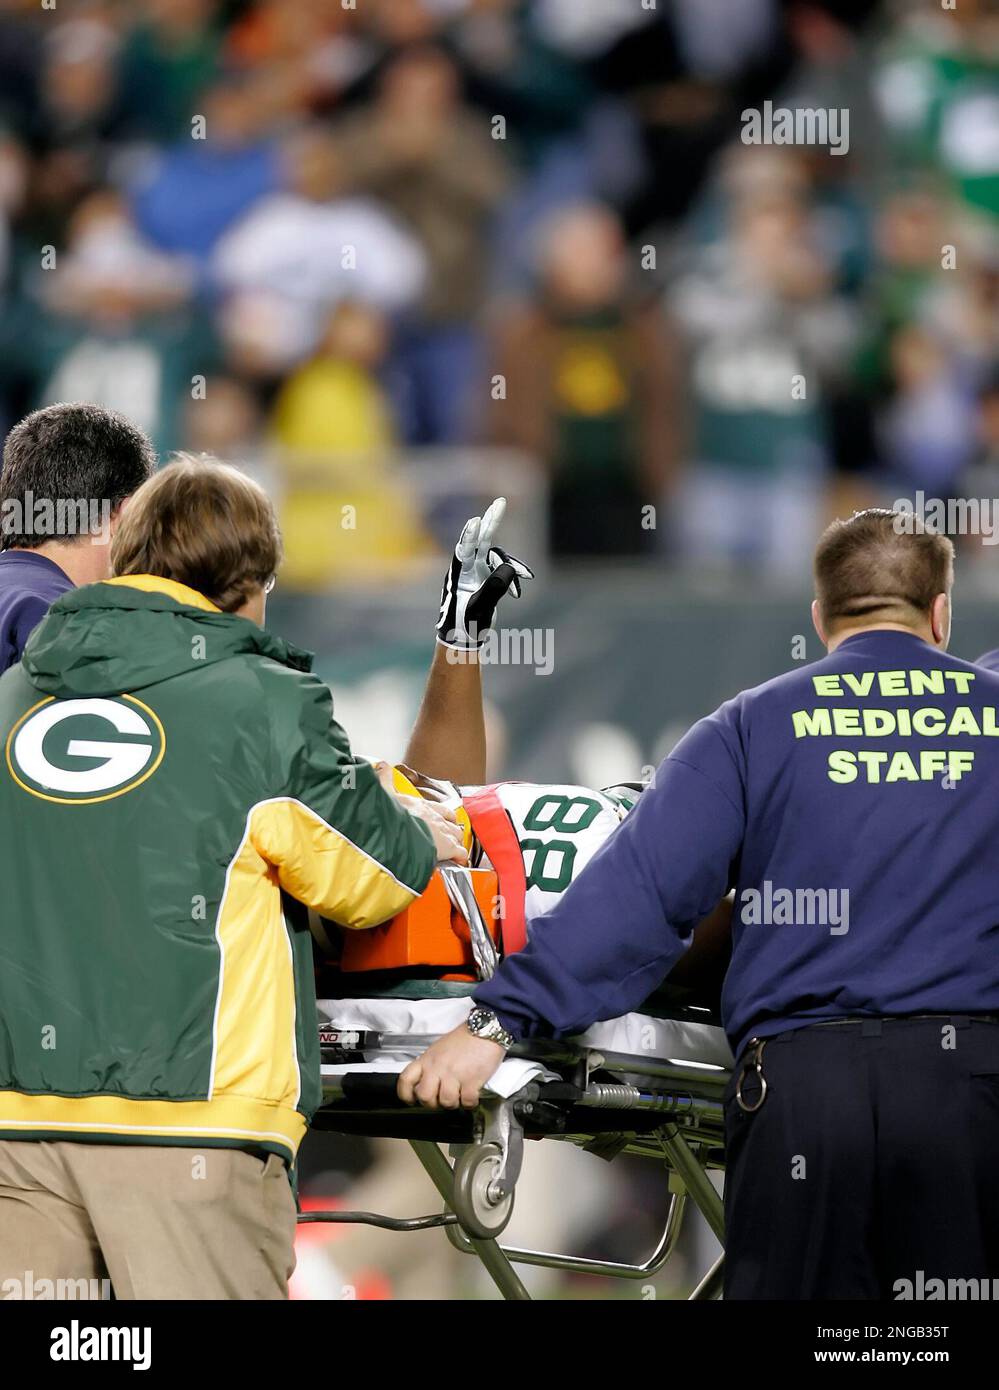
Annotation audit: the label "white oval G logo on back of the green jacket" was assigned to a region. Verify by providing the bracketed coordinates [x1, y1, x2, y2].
[7, 695, 167, 806]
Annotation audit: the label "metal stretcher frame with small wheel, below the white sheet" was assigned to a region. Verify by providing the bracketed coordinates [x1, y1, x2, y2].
[304, 1002, 731, 1301]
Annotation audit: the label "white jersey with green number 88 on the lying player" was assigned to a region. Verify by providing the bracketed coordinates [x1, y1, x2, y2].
[464, 783, 624, 927]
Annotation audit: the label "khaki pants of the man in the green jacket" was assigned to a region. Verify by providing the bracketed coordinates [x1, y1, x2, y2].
[0, 1140, 295, 1300]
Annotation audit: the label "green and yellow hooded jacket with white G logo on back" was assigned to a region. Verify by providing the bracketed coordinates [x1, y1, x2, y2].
[0, 575, 435, 1159]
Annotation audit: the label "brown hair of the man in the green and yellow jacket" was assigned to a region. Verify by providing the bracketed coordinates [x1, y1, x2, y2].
[111, 455, 281, 613]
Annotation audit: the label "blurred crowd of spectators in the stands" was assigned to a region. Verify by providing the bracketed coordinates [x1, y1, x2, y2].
[0, 0, 999, 585]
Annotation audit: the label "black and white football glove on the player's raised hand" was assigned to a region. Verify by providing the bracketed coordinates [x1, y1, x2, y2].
[438, 498, 534, 651]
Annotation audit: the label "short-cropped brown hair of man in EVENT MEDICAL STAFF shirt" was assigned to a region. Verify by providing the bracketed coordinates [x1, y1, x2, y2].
[816, 507, 955, 631]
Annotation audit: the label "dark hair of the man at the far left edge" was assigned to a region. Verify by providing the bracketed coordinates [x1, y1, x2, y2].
[0, 404, 156, 550]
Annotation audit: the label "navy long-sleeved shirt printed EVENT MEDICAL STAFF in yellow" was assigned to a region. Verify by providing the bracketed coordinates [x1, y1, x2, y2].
[475, 631, 999, 1055]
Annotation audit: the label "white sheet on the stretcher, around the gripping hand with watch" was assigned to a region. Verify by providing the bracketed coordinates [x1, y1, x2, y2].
[320, 998, 734, 1098]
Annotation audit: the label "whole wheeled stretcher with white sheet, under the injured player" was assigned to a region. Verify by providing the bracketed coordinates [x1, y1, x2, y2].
[306, 874, 734, 1300]
